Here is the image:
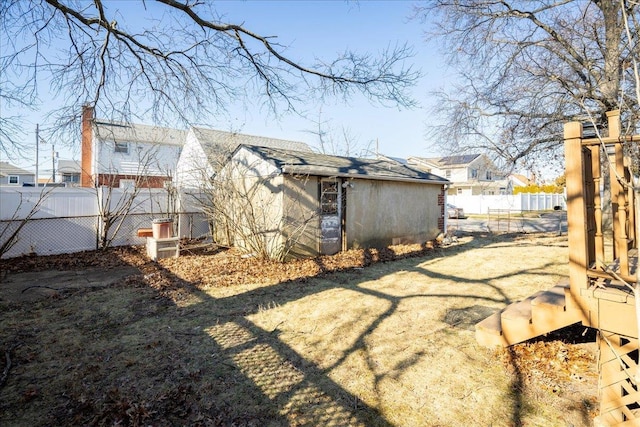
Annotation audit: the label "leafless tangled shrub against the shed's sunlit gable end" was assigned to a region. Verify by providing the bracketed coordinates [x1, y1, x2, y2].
[191, 149, 318, 261]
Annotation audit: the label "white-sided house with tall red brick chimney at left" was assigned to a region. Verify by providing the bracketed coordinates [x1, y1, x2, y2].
[80, 106, 186, 188]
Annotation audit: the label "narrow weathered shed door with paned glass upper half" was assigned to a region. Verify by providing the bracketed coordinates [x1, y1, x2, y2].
[320, 179, 342, 255]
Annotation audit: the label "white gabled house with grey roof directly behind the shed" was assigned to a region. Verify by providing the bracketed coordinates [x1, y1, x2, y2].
[175, 127, 311, 189]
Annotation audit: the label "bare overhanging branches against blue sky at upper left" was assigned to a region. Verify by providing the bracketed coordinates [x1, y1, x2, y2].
[0, 0, 419, 149]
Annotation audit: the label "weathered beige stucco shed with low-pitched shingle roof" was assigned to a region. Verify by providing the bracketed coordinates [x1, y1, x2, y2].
[208, 145, 450, 258]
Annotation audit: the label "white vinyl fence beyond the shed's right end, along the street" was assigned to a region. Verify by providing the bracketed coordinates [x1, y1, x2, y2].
[447, 193, 567, 214]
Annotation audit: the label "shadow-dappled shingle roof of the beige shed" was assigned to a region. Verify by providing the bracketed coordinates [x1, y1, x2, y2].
[242, 146, 449, 184]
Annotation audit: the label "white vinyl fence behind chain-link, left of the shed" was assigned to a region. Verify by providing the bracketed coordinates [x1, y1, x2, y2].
[0, 187, 209, 258]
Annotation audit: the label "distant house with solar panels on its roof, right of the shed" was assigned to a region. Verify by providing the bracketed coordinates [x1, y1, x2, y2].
[407, 154, 510, 195]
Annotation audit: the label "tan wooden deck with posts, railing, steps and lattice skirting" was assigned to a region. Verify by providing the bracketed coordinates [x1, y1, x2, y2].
[476, 111, 640, 427]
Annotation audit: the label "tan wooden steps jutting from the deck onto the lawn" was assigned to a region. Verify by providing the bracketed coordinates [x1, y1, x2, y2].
[476, 284, 584, 347]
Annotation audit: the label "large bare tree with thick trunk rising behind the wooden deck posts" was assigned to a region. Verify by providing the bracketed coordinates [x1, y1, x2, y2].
[416, 0, 640, 177]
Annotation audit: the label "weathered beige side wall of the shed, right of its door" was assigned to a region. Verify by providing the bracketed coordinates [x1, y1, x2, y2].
[346, 179, 442, 248]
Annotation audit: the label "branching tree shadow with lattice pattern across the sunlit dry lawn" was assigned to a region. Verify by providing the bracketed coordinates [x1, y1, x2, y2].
[131, 236, 568, 425]
